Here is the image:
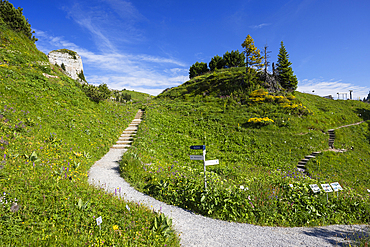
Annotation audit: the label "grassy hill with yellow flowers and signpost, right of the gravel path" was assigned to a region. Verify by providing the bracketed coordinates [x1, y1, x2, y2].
[121, 69, 370, 230]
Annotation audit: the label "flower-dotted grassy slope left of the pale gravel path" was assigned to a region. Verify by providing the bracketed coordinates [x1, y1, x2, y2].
[0, 18, 179, 246]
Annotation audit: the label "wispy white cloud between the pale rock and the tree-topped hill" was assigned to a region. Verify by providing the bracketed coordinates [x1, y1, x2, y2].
[35, 30, 189, 95]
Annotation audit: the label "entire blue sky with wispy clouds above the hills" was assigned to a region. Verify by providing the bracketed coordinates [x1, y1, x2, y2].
[10, 0, 370, 99]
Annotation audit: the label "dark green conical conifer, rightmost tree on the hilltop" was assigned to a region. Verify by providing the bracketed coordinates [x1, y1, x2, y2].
[276, 41, 298, 91]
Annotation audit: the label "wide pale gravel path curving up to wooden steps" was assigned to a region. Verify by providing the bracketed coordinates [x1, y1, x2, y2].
[88, 111, 366, 247]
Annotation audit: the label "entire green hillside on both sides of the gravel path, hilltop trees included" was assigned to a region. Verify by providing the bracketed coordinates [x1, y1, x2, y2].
[0, 0, 370, 246]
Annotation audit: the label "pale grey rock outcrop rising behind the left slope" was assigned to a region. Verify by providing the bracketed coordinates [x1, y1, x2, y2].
[48, 49, 83, 80]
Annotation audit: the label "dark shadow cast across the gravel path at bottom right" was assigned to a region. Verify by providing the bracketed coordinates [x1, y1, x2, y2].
[302, 226, 370, 246]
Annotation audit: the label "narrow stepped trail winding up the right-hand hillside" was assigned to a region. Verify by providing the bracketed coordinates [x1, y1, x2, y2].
[297, 121, 365, 175]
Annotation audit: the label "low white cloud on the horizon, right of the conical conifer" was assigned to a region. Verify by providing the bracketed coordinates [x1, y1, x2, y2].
[297, 79, 370, 100]
